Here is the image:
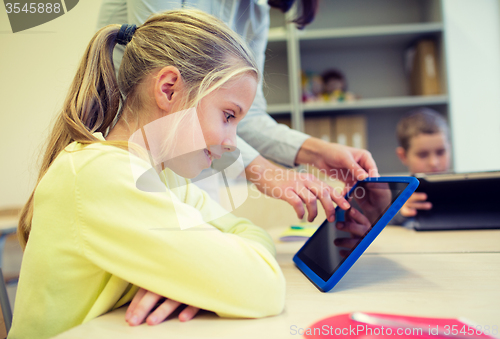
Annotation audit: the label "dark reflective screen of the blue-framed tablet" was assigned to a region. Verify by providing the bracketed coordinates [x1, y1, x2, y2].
[298, 182, 408, 281]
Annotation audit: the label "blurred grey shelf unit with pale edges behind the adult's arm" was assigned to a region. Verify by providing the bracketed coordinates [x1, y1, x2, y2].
[264, 0, 449, 174]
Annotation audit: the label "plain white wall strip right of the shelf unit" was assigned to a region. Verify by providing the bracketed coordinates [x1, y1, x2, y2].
[443, 0, 500, 172]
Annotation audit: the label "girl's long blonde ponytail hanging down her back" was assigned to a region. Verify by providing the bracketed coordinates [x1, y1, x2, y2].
[17, 25, 123, 249]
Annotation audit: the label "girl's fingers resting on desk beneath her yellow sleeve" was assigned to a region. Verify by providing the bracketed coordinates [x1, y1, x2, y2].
[125, 288, 200, 326]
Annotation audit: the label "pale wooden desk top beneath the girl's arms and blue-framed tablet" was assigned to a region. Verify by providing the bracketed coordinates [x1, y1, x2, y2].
[56, 227, 500, 339]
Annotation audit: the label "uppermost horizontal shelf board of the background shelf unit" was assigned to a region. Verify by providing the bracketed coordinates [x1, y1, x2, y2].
[298, 22, 443, 48]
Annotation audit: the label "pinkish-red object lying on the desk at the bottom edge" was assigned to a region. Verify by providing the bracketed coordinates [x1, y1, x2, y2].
[299, 312, 499, 339]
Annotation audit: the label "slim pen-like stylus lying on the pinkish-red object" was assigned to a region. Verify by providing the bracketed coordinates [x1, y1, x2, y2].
[351, 312, 490, 339]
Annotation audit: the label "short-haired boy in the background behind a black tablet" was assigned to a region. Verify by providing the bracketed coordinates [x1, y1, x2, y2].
[391, 107, 451, 225]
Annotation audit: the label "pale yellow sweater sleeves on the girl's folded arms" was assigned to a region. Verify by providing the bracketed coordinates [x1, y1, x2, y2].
[75, 152, 285, 318]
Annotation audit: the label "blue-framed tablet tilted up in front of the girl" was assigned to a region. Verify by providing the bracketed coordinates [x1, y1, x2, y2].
[293, 177, 419, 292]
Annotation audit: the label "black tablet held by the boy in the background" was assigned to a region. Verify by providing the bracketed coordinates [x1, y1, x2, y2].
[410, 171, 500, 231]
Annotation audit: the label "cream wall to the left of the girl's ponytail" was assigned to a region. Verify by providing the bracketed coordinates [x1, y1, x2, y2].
[0, 0, 102, 208]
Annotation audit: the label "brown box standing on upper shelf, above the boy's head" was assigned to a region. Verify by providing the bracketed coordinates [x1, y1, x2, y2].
[406, 39, 442, 95]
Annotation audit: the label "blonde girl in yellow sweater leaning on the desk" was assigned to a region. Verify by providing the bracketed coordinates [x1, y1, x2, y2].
[9, 10, 285, 338]
